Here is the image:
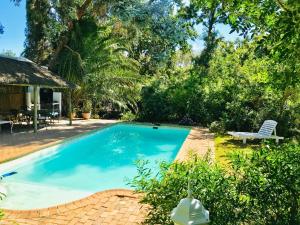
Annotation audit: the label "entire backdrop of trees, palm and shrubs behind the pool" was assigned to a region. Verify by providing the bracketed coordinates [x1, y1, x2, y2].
[20, 0, 300, 135]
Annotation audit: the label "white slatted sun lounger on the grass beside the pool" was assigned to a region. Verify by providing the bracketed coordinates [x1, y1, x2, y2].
[228, 120, 283, 144]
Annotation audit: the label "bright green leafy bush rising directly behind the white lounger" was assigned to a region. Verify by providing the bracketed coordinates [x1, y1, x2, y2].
[204, 40, 300, 135]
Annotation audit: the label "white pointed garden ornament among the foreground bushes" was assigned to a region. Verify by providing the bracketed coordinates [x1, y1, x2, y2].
[171, 182, 209, 225]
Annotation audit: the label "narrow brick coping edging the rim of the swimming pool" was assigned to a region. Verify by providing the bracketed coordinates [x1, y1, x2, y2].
[0, 121, 214, 215]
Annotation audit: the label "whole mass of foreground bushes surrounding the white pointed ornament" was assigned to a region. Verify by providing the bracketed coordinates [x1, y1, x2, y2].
[132, 144, 300, 225]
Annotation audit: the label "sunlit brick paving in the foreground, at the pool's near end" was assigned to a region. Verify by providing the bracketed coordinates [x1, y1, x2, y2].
[0, 189, 147, 225]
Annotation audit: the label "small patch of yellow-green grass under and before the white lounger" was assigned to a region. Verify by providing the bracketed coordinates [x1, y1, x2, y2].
[215, 135, 261, 167]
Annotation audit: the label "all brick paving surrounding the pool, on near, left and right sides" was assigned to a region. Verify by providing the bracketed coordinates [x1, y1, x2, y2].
[0, 120, 214, 225]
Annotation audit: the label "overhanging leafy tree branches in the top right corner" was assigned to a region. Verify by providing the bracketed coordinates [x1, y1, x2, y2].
[227, 0, 300, 89]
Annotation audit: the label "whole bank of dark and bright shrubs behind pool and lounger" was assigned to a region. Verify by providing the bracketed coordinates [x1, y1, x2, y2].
[141, 41, 300, 136]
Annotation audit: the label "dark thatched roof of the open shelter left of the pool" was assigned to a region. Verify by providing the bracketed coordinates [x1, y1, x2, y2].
[0, 55, 75, 88]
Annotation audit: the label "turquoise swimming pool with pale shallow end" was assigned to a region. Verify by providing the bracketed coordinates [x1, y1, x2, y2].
[0, 124, 189, 209]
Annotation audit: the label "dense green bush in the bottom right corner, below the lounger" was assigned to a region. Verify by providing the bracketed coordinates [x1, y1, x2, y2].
[232, 144, 300, 225]
